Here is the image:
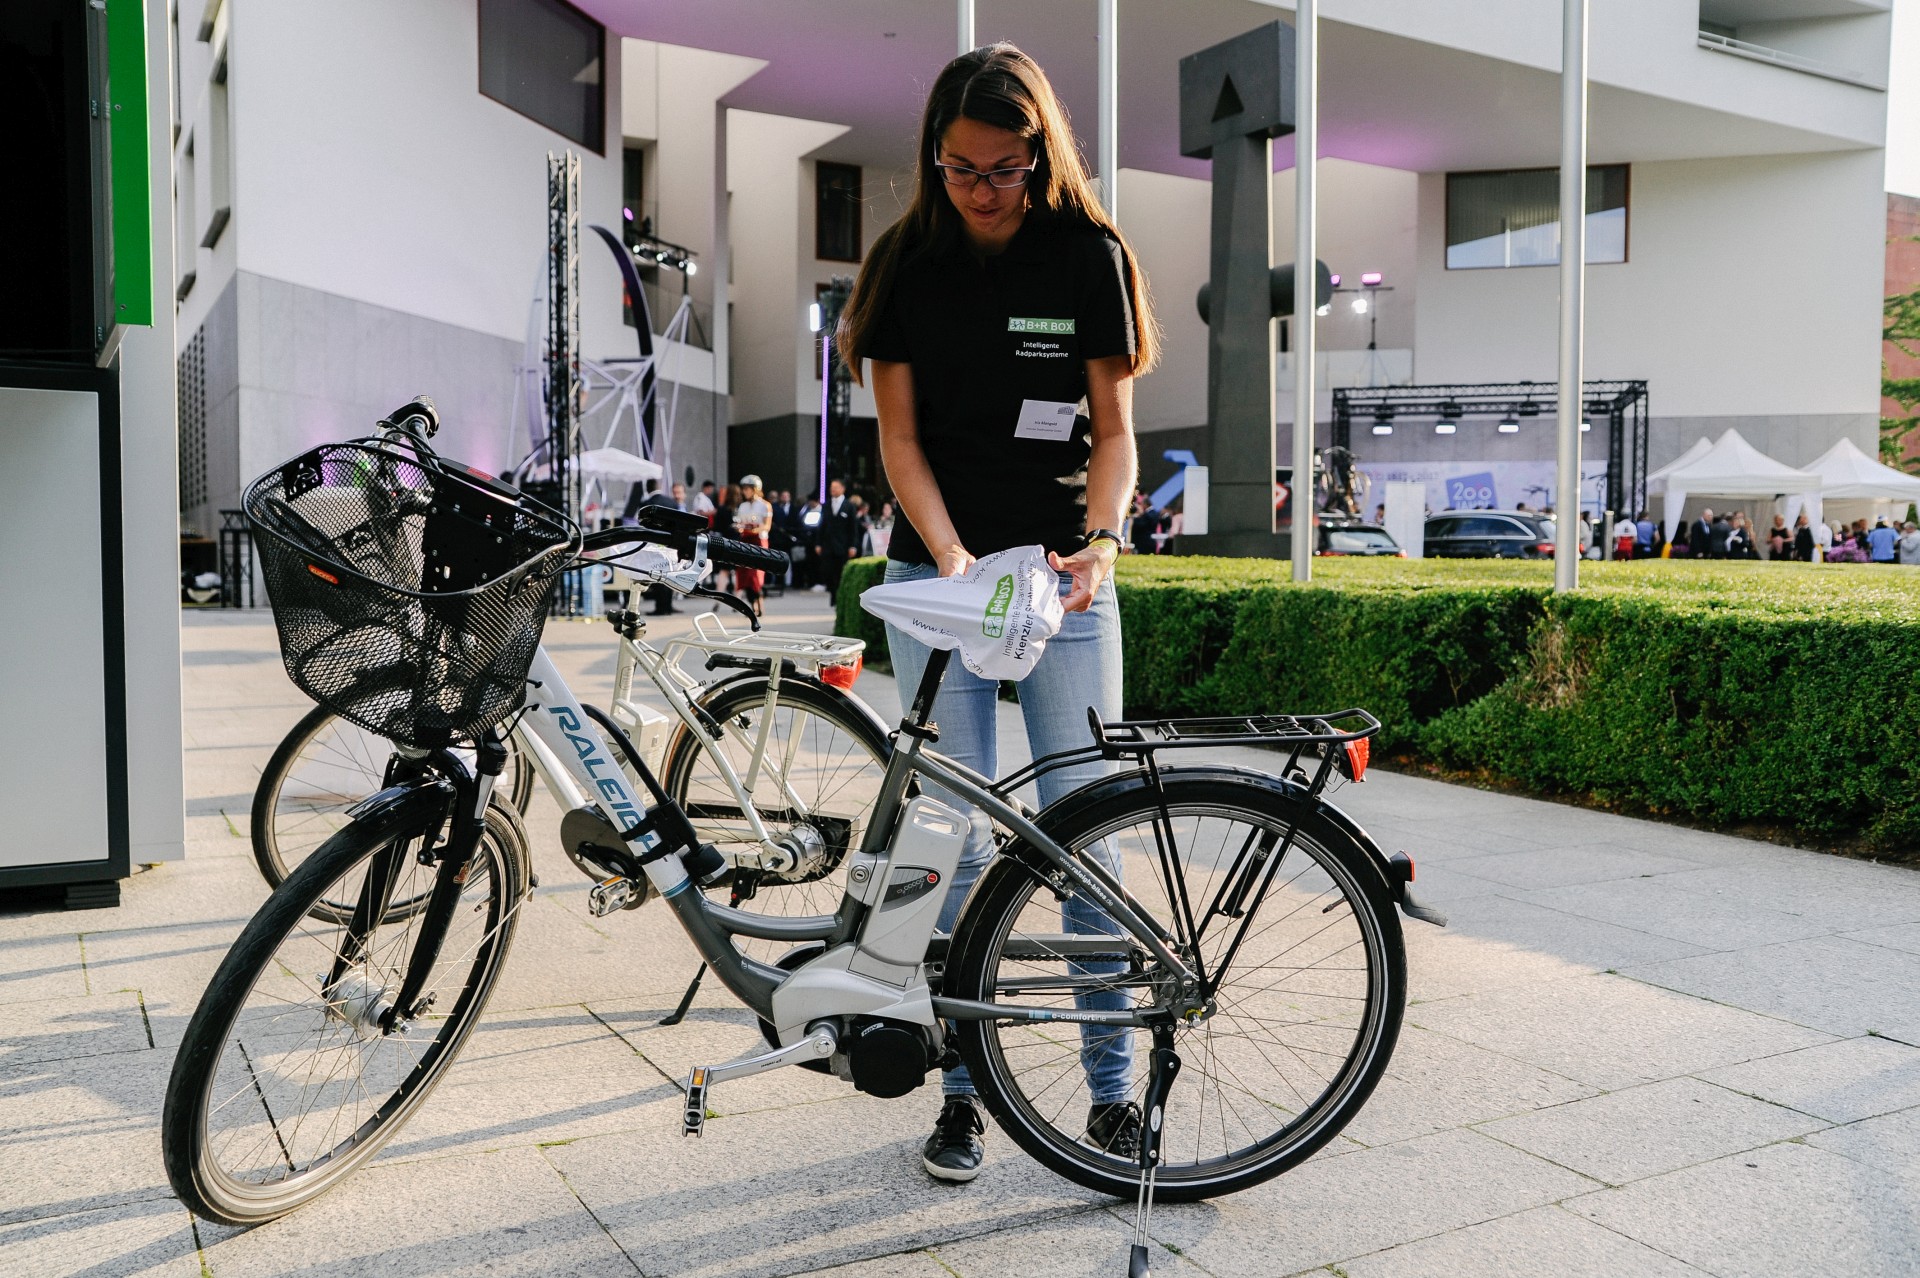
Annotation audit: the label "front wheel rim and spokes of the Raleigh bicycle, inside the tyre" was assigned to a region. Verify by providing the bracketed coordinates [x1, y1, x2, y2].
[196, 829, 518, 1213]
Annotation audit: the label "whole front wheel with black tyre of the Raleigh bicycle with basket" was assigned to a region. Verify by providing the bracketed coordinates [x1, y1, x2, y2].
[161, 802, 530, 1226]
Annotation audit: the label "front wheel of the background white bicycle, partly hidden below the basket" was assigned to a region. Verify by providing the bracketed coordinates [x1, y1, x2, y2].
[248, 706, 534, 894]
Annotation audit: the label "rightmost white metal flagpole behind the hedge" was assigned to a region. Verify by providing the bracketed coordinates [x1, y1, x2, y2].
[1553, 0, 1588, 591]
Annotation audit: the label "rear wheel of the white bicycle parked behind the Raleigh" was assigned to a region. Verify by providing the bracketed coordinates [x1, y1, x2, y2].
[660, 674, 891, 961]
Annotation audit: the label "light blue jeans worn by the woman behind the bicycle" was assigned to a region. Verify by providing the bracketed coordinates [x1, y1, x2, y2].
[887, 562, 1133, 1105]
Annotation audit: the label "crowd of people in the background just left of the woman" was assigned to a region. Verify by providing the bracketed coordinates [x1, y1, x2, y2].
[628, 474, 893, 616]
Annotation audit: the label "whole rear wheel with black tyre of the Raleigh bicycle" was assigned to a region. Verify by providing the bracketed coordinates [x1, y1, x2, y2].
[945, 769, 1407, 1201]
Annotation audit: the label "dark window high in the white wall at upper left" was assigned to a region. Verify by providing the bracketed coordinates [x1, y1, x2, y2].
[480, 0, 607, 154]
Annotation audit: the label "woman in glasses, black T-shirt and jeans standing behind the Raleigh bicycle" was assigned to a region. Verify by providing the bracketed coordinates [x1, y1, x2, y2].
[841, 44, 1158, 1180]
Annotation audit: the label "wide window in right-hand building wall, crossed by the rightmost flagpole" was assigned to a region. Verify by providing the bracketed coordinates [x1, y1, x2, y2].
[1446, 165, 1626, 271]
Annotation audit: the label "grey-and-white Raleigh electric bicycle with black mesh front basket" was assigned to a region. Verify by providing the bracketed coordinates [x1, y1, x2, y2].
[161, 401, 1430, 1274]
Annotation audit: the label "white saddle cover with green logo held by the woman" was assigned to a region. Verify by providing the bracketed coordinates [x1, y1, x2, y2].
[860, 545, 1066, 679]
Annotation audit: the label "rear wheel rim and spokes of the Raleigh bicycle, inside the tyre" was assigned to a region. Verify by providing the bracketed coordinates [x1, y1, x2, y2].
[981, 804, 1390, 1184]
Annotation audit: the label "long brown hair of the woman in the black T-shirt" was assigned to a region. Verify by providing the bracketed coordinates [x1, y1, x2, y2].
[835, 42, 1160, 382]
